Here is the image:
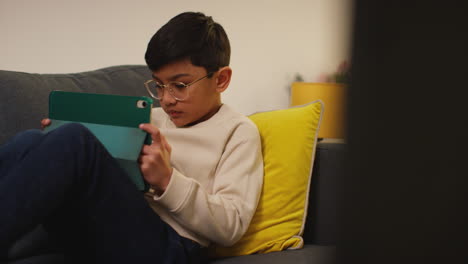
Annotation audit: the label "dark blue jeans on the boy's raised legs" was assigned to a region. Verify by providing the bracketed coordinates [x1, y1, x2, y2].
[0, 124, 202, 264]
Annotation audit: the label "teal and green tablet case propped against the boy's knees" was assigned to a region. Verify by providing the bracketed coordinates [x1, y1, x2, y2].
[45, 91, 153, 191]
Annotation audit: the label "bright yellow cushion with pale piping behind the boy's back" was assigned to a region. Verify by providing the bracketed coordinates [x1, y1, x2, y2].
[212, 100, 323, 257]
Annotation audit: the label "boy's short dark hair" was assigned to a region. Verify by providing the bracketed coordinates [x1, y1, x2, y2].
[145, 12, 231, 73]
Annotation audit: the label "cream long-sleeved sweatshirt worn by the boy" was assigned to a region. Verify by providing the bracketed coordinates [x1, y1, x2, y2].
[145, 105, 263, 246]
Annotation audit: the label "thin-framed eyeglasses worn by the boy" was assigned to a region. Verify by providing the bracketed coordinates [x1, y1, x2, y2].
[145, 72, 213, 101]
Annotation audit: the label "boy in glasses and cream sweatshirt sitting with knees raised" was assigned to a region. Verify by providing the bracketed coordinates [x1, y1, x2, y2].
[0, 12, 263, 263]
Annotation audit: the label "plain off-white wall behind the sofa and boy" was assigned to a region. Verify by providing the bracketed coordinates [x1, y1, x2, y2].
[0, 0, 351, 114]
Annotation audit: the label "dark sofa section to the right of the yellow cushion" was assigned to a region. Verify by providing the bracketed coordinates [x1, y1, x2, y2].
[303, 139, 345, 245]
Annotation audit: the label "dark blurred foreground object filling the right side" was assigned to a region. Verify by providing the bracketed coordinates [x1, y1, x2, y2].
[337, 1, 468, 264]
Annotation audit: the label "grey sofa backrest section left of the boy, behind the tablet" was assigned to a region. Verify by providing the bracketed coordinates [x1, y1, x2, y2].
[0, 65, 158, 145]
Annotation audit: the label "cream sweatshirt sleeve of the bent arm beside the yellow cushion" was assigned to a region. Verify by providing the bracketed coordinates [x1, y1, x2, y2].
[154, 122, 263, 246]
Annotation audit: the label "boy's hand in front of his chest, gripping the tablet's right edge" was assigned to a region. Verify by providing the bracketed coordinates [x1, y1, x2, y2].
[138, 124, 173, 194]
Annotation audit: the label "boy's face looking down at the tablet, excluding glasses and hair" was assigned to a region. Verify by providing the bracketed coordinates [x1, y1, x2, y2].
[153, 59, 230, 127]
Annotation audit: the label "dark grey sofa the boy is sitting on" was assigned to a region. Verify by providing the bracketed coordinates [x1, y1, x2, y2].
[0, 65, 344, 264]
